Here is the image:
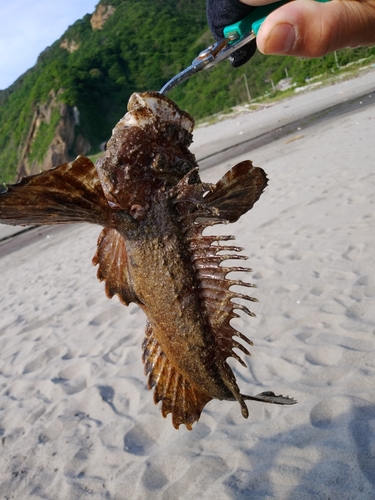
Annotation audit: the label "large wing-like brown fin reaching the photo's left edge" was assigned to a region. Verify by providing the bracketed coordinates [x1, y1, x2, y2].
[0, 156, 113, 226]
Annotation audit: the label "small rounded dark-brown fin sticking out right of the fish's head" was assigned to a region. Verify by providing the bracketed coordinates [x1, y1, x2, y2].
[205, 160, 267, 222]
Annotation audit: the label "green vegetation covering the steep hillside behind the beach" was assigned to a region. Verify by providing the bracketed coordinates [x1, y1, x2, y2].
[0, 0, 375, 182]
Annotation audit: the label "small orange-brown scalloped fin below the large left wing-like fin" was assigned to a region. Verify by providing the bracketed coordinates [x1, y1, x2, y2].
[92, 228, 138, 305]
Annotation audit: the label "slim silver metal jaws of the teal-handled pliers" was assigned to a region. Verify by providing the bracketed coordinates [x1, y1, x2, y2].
[159, 33, 255, 95]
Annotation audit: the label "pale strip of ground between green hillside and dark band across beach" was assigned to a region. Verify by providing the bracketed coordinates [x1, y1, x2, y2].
[0, 68, 375, 248]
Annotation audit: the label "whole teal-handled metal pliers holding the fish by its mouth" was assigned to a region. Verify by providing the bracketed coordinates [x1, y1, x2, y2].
[159, 0, 329, 95]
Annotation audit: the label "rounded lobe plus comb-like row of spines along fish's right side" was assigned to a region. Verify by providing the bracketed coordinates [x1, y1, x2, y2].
[174, 166, 267, 418]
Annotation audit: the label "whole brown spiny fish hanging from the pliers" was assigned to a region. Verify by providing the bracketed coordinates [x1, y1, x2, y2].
[0, 92, 296, 430]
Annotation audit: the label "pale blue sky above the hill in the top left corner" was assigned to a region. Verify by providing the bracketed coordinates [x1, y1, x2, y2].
[0, 0, 99, 90]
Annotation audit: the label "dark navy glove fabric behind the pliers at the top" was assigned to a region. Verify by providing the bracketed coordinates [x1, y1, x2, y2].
[207, 0, 256, 68]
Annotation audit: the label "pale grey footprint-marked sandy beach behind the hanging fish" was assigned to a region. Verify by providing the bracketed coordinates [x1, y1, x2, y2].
[0, 70, 375, 500]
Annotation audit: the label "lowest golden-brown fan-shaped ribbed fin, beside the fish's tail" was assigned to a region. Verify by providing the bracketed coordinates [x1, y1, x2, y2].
[142, 322, 212, 430]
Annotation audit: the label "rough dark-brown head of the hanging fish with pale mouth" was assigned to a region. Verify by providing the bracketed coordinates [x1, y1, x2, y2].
[96, 92, 197, 219]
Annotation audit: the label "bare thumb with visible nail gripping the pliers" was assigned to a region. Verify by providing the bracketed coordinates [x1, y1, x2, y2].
[257, 0, 375, 57]
